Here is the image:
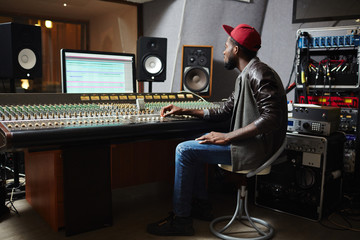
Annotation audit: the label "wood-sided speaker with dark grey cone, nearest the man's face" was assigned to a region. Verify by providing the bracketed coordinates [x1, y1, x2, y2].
[181, 45, 213, 97]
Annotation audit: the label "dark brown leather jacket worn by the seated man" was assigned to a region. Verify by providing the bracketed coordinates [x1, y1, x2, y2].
[208, 58, 287, 170]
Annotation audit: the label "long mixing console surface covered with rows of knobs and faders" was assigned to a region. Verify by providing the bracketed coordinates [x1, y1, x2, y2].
[0, 93, 225, 149]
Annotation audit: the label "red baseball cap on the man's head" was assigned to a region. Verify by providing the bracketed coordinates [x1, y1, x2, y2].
[223, 24, 261, 52]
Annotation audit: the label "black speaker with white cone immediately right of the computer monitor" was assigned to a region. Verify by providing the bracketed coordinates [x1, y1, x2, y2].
[136, 37, 167, 82]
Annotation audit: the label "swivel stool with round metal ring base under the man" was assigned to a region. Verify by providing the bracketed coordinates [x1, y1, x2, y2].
[210, 138, 286, 240]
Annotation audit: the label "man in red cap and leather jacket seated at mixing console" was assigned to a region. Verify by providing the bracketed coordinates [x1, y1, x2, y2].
[147, 24, 287, 235]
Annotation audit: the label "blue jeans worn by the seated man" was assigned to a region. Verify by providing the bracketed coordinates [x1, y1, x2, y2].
[173, 140, 231, 217]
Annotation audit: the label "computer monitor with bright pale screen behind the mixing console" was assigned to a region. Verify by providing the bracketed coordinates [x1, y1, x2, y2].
[60, 49, 136, 93]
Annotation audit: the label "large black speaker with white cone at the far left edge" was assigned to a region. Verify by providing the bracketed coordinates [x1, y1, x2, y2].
[0, 23, 42, 79]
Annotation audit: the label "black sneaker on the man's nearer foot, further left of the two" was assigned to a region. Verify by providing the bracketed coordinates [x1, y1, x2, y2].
[147, 213, 195, 236]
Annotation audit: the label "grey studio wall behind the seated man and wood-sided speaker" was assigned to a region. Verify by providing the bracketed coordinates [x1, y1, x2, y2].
[143, 0, 356, 100]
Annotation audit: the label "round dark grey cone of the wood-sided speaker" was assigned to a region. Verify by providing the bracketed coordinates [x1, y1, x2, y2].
[184, 68, 209, 92]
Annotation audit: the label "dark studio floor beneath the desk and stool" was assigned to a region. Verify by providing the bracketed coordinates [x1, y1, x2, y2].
[0, 183, 360, 240]
